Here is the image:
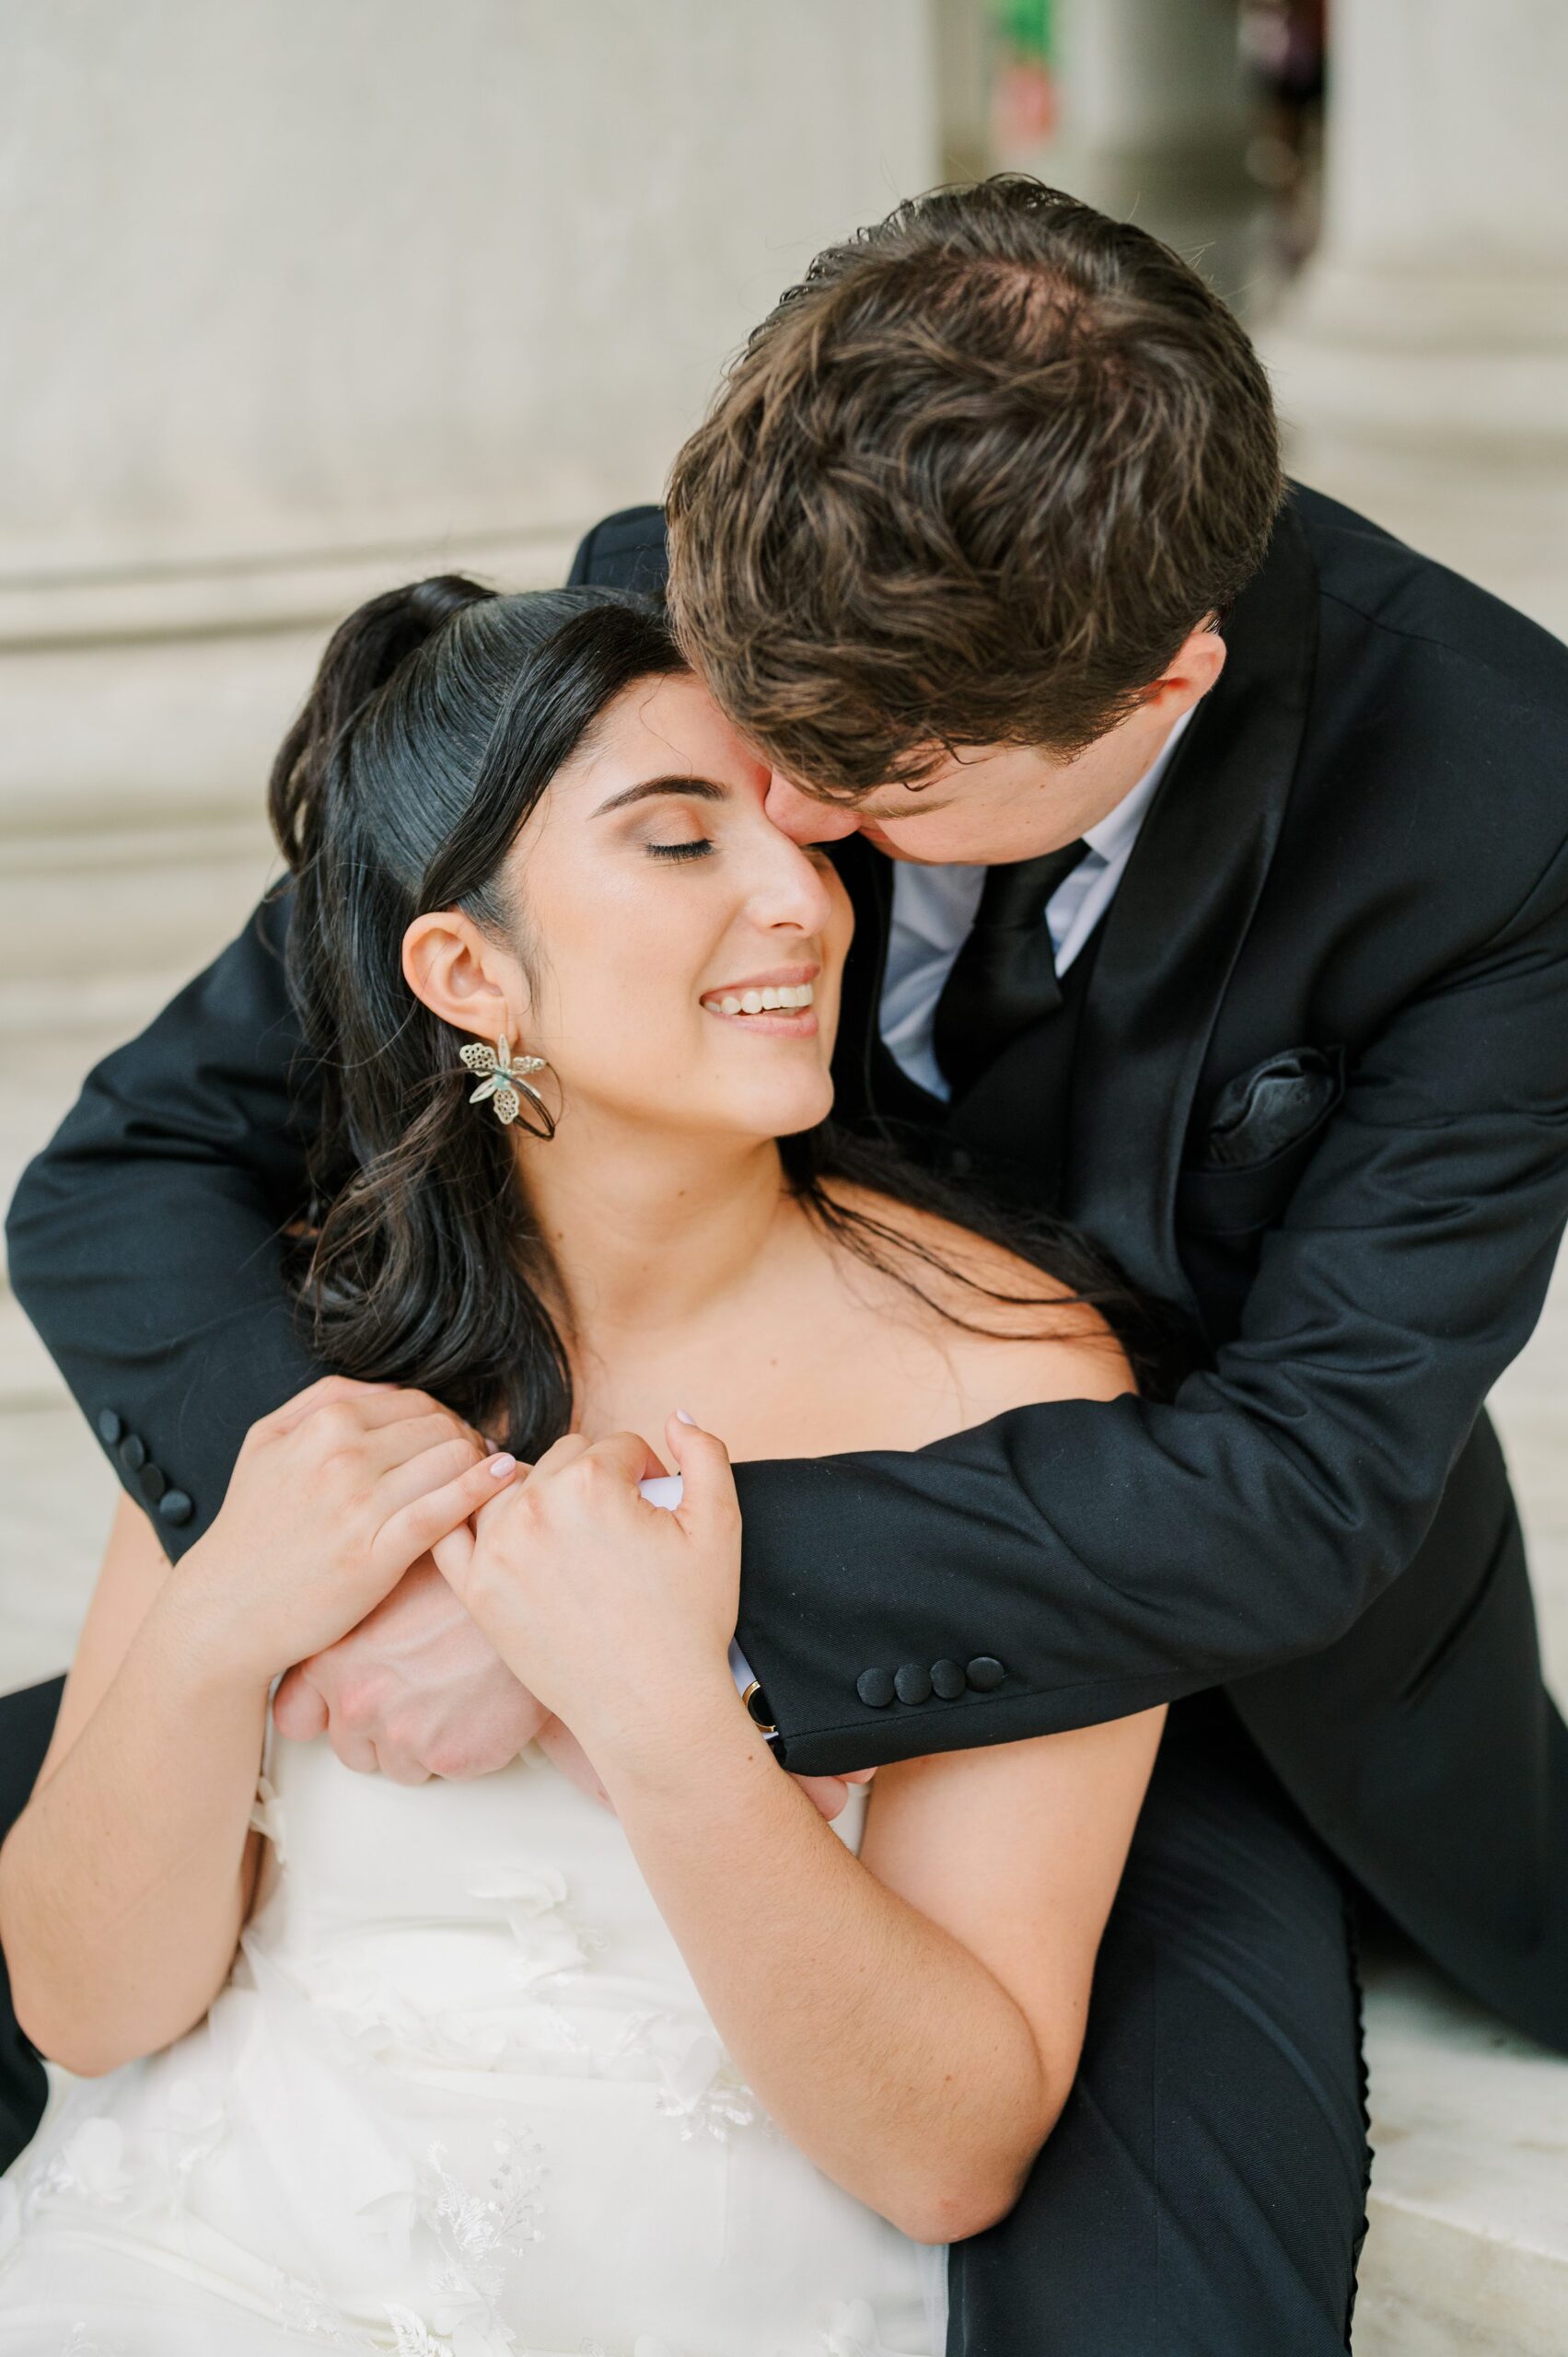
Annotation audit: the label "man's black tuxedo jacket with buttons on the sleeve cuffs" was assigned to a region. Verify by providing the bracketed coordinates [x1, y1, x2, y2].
[9, 478, 1568, 2046]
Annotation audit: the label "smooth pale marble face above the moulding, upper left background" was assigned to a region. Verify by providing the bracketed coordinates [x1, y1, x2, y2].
[0, 0, 936, 594]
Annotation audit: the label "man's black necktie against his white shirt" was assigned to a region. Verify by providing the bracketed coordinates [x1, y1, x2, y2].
[932, 842, 1089, 1096]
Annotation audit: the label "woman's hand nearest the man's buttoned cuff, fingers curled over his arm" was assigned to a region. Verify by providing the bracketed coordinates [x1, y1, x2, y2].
[441, 1417, 740, 1765]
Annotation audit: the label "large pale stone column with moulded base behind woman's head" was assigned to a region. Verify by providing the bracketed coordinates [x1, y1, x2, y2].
[0, 0, 938, 988]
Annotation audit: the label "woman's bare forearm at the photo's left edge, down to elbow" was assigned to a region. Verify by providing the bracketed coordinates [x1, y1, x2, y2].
[0, 1574, 266, 2076]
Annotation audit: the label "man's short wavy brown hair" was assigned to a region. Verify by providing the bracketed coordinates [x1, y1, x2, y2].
[668, 174, 1283, 799]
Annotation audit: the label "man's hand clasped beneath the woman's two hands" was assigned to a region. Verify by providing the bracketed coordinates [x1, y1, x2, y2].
[263, 1556, 547, 1784]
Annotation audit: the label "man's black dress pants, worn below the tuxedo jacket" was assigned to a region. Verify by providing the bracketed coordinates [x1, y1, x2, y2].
[0, 1680, 1367, 2357]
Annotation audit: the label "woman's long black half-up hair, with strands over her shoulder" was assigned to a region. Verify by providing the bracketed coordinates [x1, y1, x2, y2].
[269, 575, 1174, 1457]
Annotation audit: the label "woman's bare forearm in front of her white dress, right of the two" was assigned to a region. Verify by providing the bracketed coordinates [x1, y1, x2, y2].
[587, 1683, 1066, 2242]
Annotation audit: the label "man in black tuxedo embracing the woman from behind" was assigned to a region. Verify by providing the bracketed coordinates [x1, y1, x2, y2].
[5, 180, 1568, 2357]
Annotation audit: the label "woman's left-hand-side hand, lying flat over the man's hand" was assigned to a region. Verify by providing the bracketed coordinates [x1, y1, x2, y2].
[180, 1374, 514, 1680]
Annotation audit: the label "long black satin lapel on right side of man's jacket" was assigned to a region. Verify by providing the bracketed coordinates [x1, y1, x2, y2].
[1063, 509, 1316, 1308]
